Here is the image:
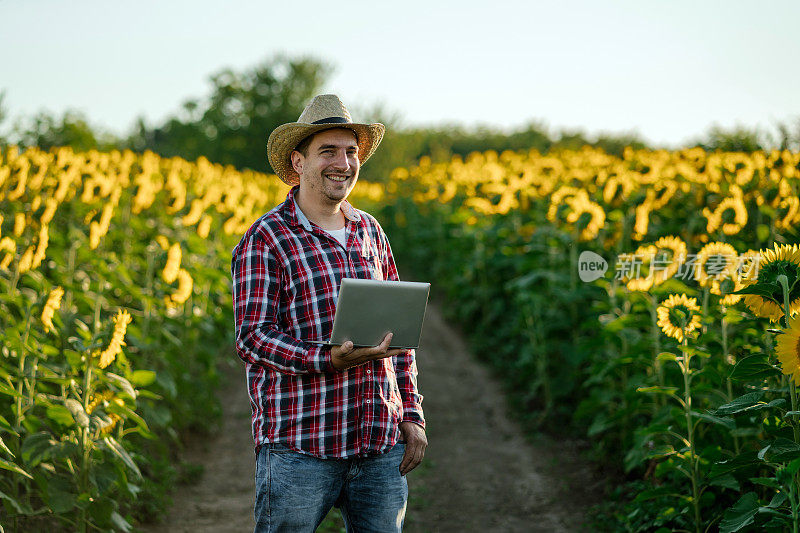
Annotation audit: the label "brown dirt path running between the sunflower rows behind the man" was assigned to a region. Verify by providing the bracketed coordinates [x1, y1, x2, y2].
[139, 305, 601, 533]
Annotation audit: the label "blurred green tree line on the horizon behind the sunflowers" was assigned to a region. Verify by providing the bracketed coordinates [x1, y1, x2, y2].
[0, 55, 800, 181]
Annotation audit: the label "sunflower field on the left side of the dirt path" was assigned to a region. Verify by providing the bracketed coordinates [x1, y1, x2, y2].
[0, 143, 379, 532]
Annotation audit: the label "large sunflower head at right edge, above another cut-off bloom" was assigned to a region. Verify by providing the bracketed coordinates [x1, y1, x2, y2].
[742, 244, 800, 322]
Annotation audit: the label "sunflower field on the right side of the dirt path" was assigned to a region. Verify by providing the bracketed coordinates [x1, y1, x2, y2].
[382, 147, 800, 532]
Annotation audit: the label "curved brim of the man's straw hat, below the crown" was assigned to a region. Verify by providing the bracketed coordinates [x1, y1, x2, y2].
[267, 122, 386, 186]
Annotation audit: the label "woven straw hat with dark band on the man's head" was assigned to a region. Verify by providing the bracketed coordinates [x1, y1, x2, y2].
[267, 94, 385, 185]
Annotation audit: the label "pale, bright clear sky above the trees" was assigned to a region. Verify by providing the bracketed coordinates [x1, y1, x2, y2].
[0, 0, 800, 147]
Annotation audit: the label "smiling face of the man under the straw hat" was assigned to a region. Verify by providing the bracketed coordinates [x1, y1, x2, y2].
[292, 128, 359, 204]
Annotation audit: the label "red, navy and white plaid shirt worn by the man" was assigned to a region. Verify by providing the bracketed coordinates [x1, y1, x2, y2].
[231, 187, 425, 458]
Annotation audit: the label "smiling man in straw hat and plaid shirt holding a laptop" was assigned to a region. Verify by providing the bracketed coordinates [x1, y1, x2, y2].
[231, 95, 427, 532]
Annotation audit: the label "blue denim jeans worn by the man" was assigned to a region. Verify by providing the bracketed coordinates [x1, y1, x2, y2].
[255, 442, 408, 533]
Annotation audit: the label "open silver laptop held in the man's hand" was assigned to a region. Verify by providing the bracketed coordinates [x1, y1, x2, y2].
[309, 278, 431, 348]
